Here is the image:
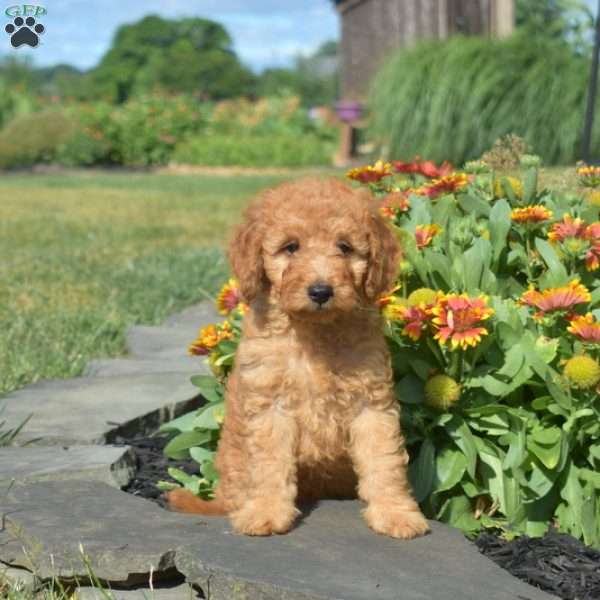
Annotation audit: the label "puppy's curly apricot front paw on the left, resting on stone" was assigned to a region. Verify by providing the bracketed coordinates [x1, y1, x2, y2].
[230, 500, 300, 535]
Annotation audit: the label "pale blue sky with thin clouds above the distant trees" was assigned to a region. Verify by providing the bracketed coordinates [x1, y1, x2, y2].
[0, 0, 338, 71]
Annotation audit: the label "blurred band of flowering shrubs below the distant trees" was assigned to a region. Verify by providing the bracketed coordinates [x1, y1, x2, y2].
[0, 94, 336, 168]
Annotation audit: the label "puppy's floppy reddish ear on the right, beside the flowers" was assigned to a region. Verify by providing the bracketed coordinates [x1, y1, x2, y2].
[365, 206, 401, 300]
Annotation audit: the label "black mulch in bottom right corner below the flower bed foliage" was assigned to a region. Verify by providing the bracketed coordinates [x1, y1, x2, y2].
[475, 531, 600, 600]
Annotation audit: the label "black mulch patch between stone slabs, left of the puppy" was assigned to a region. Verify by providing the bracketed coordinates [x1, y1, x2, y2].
[116, 436, 199, 506]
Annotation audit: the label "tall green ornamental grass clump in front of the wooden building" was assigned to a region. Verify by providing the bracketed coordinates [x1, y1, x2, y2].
[370, 34, 600, 164]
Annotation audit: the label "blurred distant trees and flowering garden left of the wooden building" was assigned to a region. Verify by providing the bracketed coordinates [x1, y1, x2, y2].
[0, 16, 337, 169]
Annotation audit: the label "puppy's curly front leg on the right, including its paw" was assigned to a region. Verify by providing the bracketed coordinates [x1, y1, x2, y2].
[351, 407, 429, 539]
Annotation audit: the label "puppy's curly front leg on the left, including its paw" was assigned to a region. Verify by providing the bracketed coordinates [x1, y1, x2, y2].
[230, 406, 299, 535]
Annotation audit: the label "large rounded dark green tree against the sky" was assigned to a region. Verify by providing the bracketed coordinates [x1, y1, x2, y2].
[91, 15, 254, 102]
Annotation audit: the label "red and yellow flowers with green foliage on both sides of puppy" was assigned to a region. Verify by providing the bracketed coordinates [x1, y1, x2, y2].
[159, 156, 600, 546]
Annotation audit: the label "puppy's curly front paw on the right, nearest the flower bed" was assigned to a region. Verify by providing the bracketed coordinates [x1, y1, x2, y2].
[363, 502, 429, 540]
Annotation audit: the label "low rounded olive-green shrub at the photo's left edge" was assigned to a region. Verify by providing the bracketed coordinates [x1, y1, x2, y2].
[0, 108, 73, 169]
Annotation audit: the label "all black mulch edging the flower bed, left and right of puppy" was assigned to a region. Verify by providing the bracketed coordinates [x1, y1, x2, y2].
[117, 436, 600, 600]
